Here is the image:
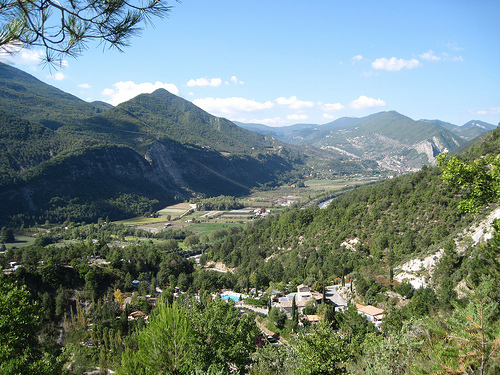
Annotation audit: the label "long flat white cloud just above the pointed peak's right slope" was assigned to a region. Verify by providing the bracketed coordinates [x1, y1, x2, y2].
[193, 97, 274, 114]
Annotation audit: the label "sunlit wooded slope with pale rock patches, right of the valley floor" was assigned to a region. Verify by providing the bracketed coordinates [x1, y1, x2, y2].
[205, 164, 472, 285]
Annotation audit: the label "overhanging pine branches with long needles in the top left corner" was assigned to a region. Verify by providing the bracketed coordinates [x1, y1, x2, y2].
[0, 0, 180, 65]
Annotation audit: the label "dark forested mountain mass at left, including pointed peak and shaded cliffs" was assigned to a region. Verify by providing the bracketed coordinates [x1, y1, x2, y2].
[0, 65, 304, 223]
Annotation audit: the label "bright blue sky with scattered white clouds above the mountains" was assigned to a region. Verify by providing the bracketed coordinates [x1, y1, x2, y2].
[2, 0, 500, 126]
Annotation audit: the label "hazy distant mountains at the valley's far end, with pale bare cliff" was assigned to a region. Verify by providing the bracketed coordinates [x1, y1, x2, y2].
[236, 111, 496, 173]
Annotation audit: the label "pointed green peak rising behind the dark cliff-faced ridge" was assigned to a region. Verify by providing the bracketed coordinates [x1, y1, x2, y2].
[72, 89, 283, 153]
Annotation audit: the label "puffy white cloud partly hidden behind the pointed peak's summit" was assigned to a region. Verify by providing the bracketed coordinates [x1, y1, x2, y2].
[101, 81, 179, 105]
